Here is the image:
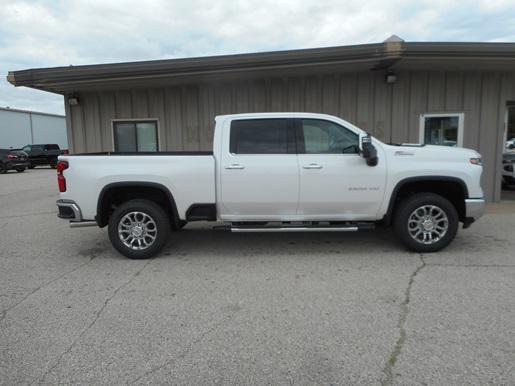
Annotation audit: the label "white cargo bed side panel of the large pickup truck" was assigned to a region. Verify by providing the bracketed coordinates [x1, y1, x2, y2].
[61, 152, 216, 225]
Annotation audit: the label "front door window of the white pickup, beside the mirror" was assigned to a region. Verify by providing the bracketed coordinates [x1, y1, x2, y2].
[302, 119, 359, 154]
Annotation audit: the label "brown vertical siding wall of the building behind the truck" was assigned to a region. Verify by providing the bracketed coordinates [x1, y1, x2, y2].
[66, 71, 515, 200]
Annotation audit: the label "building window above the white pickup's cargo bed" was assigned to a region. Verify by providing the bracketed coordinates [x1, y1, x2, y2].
[113, 121, 159, 152]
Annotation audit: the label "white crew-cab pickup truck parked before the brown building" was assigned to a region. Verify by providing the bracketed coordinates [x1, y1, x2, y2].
[57, 113, 485, 258]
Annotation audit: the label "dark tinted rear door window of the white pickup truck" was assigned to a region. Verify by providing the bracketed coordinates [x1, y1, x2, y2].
[230, 119, 295, 154]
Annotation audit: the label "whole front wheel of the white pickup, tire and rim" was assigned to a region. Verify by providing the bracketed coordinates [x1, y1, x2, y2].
[394, 193, 459, 252]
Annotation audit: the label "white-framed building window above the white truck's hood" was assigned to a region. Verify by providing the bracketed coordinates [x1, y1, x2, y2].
[419, 113, 464, 147]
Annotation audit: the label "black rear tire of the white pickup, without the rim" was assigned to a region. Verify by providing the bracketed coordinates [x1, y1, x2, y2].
[108, 199, 170, 259]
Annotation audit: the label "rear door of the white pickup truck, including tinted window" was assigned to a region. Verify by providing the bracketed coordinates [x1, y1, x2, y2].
[220, 118, 299, 221]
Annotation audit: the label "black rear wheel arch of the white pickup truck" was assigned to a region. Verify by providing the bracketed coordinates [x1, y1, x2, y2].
[95, 181, 180, 228]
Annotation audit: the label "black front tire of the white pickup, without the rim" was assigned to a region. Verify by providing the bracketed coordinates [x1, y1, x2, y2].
[394, 193, 459, 253]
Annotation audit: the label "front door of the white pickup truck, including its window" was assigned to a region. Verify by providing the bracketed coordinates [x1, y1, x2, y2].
[295, 119, 386, 220]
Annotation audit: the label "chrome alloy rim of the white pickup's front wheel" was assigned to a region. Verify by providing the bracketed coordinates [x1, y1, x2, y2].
[408, 205, 449, 244]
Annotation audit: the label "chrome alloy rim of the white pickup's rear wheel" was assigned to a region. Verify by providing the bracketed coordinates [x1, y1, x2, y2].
[118, 212, 157, 251]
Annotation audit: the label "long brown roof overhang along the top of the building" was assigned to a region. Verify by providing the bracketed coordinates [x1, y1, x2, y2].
[7, 41, 515, 94]
